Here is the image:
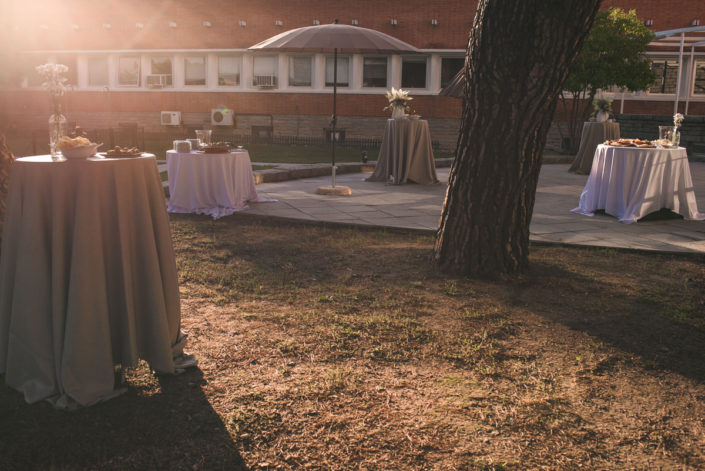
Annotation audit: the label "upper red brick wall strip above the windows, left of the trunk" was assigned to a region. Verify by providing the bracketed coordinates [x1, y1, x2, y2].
[0, 0, 477, 50]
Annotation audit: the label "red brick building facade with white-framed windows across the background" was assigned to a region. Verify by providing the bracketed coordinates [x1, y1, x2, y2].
[0, 0, 705, 149]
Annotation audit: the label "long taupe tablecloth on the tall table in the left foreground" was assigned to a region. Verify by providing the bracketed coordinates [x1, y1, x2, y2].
[0, 155, 183, 407]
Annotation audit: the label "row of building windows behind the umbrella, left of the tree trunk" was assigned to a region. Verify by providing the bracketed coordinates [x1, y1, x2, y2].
[19, 54, 464, 89]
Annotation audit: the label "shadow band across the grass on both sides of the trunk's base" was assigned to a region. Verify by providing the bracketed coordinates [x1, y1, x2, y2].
[174, 215, 705, 383]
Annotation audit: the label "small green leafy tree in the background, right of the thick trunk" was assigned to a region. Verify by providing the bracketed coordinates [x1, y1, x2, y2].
[558, 8, 656, 154]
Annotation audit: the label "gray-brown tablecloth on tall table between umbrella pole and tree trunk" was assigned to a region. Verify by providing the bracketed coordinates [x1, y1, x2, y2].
[367, 119, 438, 185]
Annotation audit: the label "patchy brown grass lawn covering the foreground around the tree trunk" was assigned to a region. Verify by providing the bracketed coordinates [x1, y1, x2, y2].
[0, 215, 705, 470]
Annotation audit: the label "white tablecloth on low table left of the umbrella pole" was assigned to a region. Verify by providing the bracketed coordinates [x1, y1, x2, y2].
[166, 150, 273, 219]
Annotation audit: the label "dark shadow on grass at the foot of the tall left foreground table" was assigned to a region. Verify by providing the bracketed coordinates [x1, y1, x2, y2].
[0, 366, 247, 471]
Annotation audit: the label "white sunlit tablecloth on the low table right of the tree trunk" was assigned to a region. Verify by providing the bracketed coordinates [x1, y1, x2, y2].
[572, 145, 705, 223]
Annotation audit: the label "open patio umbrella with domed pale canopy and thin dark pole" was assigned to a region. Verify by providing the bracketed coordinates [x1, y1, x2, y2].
[250, 20, 420, 192]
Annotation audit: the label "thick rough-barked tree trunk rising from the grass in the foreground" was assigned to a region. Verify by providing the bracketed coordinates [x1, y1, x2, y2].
[435, 0, 601, 276]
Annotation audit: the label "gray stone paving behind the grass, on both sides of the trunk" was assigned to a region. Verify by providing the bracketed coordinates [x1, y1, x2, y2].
[242, 162, 705, 253]
